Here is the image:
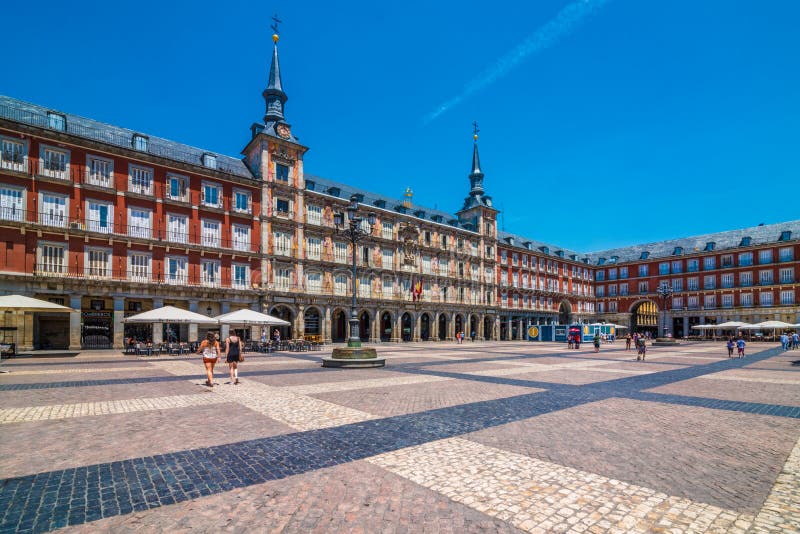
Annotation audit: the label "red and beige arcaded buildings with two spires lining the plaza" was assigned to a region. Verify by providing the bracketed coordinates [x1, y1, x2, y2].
[0, 30, 800, 350]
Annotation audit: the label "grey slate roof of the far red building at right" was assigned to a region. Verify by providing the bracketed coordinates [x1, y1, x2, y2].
[584, 220, 800, 265]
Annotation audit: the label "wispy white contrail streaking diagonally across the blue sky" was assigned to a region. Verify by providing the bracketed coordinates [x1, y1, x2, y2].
[423, 0, 608, 124]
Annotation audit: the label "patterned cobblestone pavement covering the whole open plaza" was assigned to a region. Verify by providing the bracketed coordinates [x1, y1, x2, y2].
[0, 342, 800, 533]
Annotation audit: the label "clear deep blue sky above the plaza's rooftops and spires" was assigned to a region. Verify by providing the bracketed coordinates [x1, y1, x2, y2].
[0, 0, 800, 252]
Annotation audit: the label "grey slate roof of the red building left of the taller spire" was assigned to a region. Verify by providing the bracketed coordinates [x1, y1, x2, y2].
[0, 95, 254, 179]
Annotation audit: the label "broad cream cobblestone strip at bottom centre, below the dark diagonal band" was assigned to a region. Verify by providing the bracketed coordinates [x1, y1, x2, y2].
[368, 438, 754, 533]
